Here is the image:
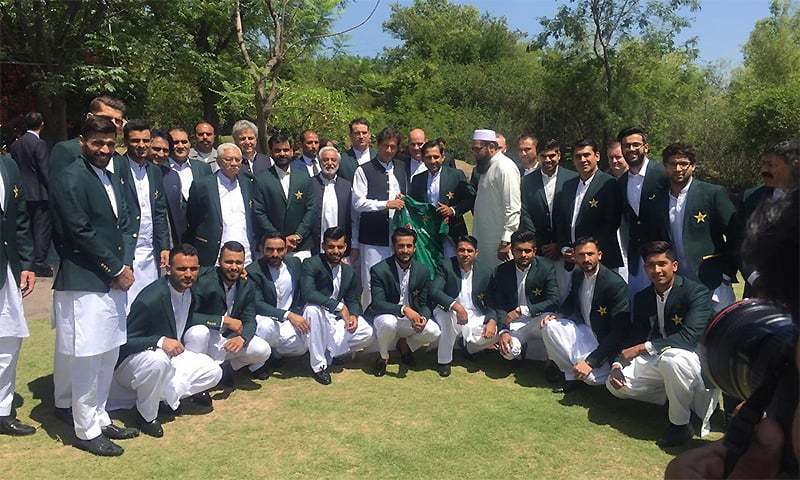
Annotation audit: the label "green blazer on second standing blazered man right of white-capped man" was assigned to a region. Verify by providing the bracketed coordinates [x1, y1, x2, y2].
[553, 170, 622, 268]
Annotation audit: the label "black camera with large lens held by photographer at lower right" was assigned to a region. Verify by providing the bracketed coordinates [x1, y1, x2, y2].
[702, 299, 798, 475]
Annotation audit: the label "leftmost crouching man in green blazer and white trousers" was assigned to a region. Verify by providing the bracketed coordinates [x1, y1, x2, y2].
[108, 244, 222, 437]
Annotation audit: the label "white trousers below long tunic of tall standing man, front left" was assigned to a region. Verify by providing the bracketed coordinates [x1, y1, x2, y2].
[53, 347, 119, 440]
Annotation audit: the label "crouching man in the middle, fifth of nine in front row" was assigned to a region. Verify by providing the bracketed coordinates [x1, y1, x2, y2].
[367, 227, 441, 377]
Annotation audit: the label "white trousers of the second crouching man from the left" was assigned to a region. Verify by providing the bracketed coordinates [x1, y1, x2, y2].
[183, 325, 272, 370]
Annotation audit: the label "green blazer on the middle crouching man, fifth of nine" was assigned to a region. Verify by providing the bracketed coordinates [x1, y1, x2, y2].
[365, 255, 433, 321]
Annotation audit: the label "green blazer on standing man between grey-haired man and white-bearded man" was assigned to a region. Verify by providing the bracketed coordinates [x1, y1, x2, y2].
[253, 165, 317, 250]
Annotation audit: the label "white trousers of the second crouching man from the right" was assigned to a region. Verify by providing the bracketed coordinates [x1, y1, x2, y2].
[542, 318, 611, 385]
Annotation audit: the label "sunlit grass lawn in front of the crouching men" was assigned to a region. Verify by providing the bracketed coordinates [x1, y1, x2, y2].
[0, 318, 720, 479]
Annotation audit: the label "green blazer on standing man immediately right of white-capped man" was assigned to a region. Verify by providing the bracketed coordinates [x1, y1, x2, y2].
[520, 166, 578, 248]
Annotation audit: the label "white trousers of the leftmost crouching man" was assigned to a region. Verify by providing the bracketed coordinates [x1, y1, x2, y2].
[108, 348, 222, 422]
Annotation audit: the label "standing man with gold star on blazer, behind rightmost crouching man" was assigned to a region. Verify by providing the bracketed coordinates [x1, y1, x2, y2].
[657, 143, 739, 313]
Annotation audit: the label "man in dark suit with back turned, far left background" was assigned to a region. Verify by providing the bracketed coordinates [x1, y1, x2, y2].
[9, 112, 53, 277]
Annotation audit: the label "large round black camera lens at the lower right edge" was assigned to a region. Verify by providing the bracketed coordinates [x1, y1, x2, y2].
[703, 299, 797, 399]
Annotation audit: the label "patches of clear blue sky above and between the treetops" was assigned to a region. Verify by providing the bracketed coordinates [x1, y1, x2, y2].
[334, 0, 769, 66]
